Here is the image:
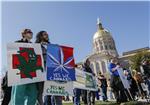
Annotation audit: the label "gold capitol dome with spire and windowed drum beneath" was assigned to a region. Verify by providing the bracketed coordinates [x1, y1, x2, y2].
[93, 19, 118, 57]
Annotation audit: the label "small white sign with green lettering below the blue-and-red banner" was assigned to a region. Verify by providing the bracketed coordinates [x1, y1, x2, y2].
[44, 81, 73, 96]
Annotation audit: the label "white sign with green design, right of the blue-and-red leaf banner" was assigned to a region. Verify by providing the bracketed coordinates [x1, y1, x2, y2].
[73, 69, 98, 91]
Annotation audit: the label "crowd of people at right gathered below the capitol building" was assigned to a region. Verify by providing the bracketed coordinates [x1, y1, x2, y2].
[74, 59, 150, 105]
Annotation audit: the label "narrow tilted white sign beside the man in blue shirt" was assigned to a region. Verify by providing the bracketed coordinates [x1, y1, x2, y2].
[117, 68, 130, 89]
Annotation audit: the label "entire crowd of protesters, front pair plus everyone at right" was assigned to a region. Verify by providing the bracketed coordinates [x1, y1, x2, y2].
[1, 29, 150, 105]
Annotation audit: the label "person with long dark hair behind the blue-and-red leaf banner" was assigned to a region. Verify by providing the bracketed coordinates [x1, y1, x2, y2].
[36, 31, 62, 105]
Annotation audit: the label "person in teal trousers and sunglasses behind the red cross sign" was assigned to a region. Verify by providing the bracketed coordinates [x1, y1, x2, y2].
[10, 29, 37, 105]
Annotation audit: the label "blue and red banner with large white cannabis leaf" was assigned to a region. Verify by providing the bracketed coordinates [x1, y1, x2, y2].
[46, 44, 76, 81]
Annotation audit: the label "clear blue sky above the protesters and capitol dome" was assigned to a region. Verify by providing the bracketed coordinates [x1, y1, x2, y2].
[2, 1, 150, 71]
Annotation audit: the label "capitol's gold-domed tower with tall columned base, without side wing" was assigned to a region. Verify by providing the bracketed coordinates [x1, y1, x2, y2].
[87, 19, 118, 75]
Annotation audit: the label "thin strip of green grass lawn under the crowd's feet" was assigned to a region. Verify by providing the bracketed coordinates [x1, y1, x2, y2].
[63, 101, 150, 105]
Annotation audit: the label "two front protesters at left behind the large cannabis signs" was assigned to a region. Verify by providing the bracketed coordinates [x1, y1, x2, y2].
[2, 29, 62, 105]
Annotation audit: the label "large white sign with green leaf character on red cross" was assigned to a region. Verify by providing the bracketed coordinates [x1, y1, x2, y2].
[7, 43, 46, 86]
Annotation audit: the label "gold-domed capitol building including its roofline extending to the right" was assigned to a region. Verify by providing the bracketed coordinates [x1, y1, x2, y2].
[77, 19, 150, 75]
